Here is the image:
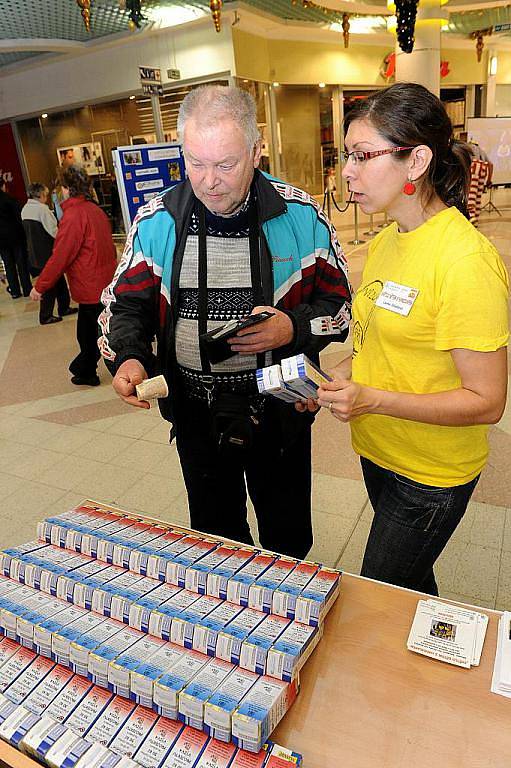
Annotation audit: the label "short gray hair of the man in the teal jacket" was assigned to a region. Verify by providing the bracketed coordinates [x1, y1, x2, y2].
[177, 85, 259, 149]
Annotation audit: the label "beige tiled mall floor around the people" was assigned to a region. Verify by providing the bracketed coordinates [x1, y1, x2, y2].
[0, 191, 511, 609]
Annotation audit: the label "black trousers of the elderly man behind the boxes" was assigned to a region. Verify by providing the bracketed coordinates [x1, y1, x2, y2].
[175, 401, 312, 558]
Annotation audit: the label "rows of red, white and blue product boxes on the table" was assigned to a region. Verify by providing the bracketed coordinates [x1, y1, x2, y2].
[0, 502, 340, 768]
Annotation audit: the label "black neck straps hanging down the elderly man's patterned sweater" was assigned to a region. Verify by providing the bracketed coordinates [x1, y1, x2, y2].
[196, 195, 265, 407]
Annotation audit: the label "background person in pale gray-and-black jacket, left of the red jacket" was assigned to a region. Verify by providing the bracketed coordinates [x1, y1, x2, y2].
[21, 182, 78, 325]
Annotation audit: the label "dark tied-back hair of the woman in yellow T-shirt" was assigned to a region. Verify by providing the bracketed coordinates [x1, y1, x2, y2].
[344, 83, 472, 218]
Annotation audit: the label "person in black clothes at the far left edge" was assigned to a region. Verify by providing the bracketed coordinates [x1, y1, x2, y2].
[0, 178, 32, 299]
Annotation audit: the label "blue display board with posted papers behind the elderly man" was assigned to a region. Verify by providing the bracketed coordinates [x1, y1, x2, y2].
[112, 143, 186, 232]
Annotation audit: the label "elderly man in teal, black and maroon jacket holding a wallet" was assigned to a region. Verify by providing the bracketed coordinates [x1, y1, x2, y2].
[100, 86, 350, 557]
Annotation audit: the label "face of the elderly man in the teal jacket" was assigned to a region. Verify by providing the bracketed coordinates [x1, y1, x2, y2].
[183, 118, 261, 216]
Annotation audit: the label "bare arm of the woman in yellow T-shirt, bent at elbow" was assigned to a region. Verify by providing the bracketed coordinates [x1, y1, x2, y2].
[317, 347, 507, 427]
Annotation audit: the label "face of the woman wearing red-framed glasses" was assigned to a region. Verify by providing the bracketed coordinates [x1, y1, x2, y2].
[342, 120, 409, 220]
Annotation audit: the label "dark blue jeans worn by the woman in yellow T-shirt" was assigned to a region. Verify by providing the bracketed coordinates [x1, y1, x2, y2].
[360, 457, 479, 595]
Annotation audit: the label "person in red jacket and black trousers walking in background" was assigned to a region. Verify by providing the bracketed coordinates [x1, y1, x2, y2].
[30, 165, 117, 387]
